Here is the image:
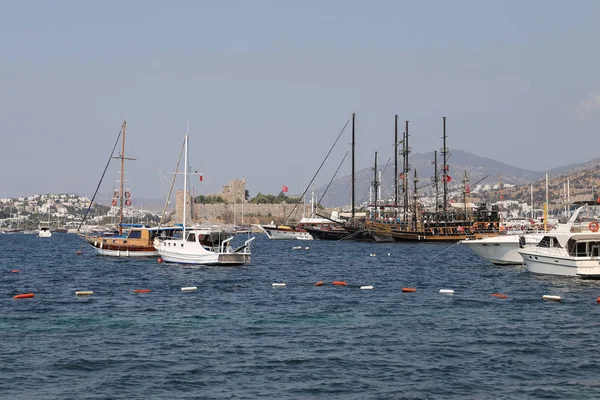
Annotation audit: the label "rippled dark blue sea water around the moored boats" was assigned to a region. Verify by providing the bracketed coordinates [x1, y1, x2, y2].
[0, 233, 600, 399]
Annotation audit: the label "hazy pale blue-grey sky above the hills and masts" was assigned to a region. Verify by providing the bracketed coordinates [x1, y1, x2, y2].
[0, 0, 600, 203]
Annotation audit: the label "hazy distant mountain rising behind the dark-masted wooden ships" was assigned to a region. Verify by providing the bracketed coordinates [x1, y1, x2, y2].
[315, 149, 600, 207]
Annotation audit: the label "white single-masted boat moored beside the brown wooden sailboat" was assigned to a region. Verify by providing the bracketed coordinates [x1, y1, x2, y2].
[154, 129, 254, 265]
